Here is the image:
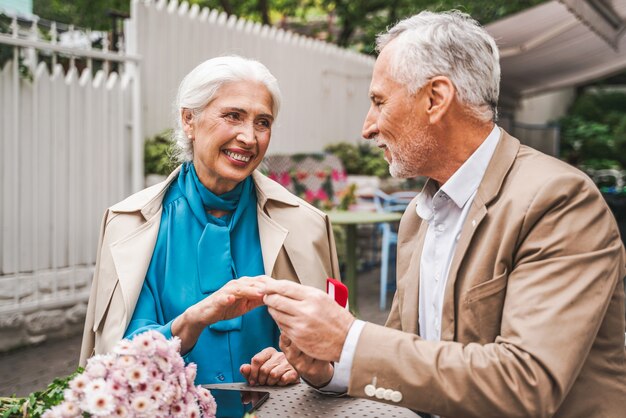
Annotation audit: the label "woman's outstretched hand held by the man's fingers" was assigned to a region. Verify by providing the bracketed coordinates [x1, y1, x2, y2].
[172, 277, 263, 354]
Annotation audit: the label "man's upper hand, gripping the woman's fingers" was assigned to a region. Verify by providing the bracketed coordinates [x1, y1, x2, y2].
[263, 280, 354, 362]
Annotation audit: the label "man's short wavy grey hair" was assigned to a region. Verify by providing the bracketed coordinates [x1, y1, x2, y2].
[376, 10, 500, 121]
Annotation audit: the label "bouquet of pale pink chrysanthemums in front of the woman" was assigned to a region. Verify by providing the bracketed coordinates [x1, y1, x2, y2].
[43, 331, 217, 418]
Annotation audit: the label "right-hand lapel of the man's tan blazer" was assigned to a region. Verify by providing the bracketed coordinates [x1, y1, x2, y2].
[441, 129, 520, 341]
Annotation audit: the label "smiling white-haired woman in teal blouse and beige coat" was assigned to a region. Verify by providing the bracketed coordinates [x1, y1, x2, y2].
[81, 56, 339, 384]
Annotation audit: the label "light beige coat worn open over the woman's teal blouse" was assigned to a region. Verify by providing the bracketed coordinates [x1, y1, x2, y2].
[80, 169, 339, 365]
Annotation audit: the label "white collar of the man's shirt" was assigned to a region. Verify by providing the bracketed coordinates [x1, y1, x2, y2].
[415, 125, 500, 222]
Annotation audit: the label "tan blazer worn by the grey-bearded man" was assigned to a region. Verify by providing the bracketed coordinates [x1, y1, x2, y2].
[349, 131, 626, 418]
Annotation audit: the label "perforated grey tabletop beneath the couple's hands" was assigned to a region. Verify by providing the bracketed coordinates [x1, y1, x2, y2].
[203, 383, 419, 418]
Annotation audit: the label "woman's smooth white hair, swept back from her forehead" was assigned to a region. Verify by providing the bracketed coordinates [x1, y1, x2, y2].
[172, 55, 281, 162]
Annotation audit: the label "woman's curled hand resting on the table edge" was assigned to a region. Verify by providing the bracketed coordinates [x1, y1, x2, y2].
[239, 347, 299, 386]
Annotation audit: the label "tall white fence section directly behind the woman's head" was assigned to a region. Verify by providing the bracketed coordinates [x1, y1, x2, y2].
[127, 0, 374, 154]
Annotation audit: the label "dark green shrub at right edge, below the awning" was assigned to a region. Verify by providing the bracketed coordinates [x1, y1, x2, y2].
[560, 92, 626, 170]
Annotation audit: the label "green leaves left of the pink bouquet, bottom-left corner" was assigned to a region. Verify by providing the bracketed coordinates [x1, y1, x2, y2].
[0, 367, 83, 418]
